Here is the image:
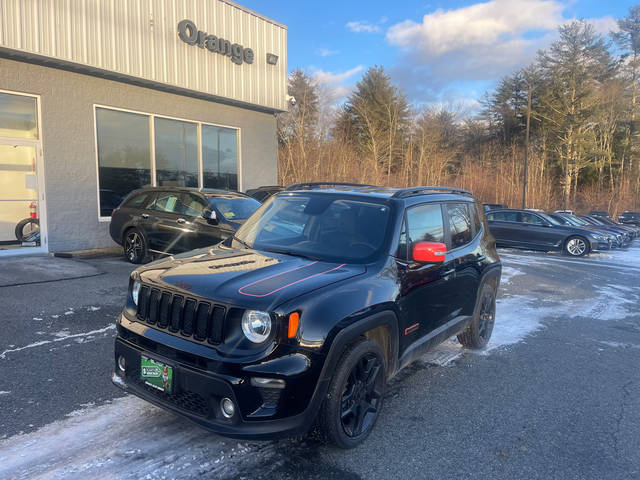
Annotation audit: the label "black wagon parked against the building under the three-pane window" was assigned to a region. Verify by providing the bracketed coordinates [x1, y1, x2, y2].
[109, 187, 260, 263]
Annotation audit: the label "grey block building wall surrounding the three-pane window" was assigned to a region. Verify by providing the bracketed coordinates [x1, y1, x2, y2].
[0, 58, 277, 252]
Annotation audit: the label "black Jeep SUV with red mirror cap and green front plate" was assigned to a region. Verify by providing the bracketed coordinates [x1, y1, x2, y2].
[112, 183, 501, 447]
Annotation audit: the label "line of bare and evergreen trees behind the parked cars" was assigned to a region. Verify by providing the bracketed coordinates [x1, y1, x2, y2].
[278, 6, 640, 215]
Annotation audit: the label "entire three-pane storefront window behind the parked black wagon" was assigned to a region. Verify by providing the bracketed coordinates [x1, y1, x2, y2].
[96, 106, 239, 217]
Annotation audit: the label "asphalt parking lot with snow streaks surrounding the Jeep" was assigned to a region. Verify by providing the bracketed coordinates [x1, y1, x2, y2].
[0, 246, 640, 479]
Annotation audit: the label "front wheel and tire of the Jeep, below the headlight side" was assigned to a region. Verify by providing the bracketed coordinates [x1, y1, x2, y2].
[318, 339, 387, 448]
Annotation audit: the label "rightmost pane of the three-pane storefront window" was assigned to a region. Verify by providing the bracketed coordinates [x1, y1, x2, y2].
[202, 125, 238, 190]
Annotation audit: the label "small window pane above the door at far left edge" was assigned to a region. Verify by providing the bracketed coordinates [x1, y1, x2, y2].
[0, 93, 38, 138]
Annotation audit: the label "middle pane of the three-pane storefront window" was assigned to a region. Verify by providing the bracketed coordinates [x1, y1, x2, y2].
[154, 118, 198, 187]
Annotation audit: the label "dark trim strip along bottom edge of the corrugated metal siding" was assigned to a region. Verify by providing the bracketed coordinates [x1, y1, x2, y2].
[0, 47, 285, 114]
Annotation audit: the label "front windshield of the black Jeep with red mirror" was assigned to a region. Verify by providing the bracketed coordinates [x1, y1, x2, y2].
[232, 194, 390, 263]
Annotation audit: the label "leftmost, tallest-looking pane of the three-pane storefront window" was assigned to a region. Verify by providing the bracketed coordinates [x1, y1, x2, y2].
[96, 108, 151, 217]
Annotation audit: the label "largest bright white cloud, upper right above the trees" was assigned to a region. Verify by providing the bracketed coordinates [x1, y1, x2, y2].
[386, 0, 616, 101]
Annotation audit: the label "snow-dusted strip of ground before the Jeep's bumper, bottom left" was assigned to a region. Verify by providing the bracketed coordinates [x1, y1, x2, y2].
[0, 396, 274, 480]
